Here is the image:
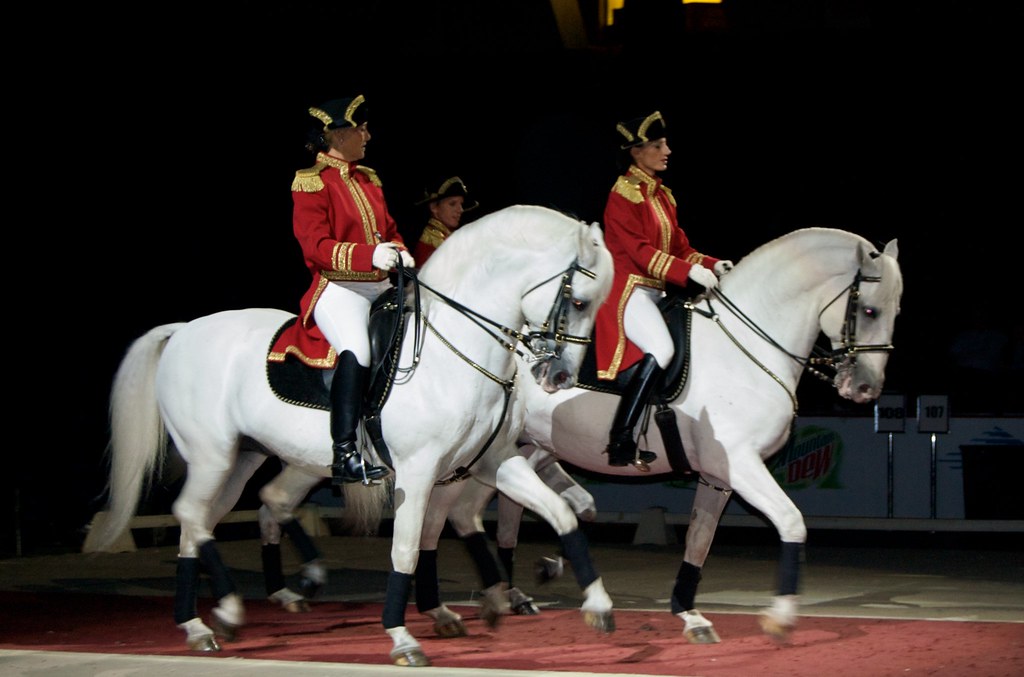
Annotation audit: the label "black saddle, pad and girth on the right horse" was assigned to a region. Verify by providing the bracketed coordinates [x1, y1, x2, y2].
[577, 294, 693, 475]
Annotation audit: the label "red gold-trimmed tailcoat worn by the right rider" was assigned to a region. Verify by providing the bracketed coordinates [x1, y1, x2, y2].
[594, 165, 719, 380]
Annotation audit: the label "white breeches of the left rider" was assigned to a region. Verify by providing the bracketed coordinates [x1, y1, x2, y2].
[313, 280, 391, 367]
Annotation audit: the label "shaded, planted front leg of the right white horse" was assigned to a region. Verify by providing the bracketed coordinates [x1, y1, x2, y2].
[672, 478, 732, 644]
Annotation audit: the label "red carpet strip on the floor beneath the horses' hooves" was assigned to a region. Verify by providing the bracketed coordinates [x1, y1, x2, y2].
[0, 592, 1024, 677]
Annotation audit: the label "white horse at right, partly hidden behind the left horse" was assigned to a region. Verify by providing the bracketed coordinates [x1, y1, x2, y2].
[436, 228, 903, 643]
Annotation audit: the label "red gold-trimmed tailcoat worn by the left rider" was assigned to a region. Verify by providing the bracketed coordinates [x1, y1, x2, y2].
[268, 153, 406, 369]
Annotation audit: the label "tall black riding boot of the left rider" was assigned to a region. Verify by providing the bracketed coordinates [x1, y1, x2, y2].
[331, 350, 388, 484]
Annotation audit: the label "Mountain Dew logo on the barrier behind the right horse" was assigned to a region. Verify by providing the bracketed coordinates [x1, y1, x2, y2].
[769, 425, 843, 489]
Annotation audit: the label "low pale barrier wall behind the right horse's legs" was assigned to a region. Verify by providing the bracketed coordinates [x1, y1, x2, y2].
[577, 417, 1024, 519]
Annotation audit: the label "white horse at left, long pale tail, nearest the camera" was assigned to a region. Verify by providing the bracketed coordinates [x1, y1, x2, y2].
[90, 206, 614, 666]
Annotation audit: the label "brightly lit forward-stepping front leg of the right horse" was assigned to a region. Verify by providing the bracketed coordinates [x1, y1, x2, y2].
[732, 463, 807, 641]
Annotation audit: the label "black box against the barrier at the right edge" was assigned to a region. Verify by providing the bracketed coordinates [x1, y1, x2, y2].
[961, 445, 1024, 519]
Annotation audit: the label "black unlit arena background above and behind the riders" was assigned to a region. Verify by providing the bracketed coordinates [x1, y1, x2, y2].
[9, 0, 1024, 553]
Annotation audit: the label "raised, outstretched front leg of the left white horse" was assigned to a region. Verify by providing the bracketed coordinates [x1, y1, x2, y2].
[496, 455, 615, 632]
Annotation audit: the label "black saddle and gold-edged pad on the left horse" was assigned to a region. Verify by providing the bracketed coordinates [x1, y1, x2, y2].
[266, 276, 406, 465]
